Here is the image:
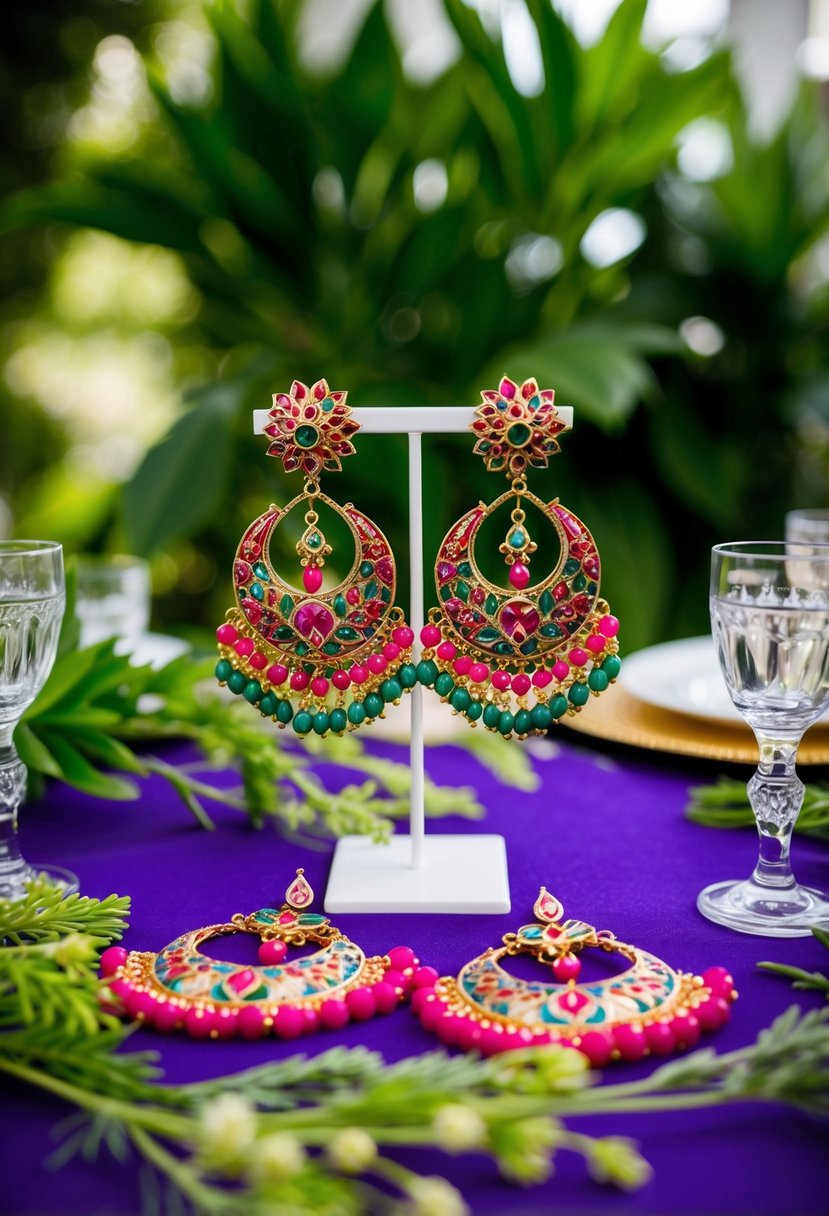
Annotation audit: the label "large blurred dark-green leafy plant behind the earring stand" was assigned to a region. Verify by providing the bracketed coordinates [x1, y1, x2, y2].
[0, 0, 829, 649]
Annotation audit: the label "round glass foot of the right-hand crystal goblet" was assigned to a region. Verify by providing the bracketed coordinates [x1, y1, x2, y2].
[697, 878, 829, 938]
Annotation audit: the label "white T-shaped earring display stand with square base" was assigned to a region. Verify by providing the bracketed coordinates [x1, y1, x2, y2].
[253, 405, 573, 913]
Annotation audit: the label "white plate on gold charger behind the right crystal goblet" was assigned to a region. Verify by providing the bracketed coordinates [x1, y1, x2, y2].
[619, 636, 743, 724]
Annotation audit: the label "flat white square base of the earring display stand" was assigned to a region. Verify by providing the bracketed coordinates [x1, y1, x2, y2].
[325, 835, 509, 913]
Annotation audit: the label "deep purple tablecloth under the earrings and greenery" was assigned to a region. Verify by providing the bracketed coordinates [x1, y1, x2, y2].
[0, 744, 829, 1216]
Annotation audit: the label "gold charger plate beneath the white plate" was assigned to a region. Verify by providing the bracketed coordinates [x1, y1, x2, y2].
[566, 687, 829, 765]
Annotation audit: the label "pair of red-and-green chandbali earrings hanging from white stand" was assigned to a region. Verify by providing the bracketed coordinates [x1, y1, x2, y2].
[215, 377, 620, 738]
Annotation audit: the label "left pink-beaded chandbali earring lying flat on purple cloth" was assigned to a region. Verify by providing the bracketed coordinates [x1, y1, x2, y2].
[101, 869, 438, 1038]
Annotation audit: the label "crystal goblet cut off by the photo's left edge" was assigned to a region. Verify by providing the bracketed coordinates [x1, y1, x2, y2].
[0, 540, 78, 900]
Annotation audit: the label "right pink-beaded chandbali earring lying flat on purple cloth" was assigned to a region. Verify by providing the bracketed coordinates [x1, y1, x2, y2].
[412, 886, 737, 1068]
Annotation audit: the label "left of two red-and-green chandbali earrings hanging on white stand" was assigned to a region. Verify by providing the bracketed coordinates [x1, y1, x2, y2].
[216, 379, 417, 734]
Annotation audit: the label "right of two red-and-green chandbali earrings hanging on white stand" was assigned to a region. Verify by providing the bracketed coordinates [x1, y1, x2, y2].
[417, 377, 621, 738]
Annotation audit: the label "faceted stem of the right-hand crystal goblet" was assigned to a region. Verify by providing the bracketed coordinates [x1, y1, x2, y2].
[746, 732, 805, 890]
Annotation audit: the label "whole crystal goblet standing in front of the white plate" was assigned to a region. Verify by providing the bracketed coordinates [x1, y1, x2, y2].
[697, 541, 829, 938]
